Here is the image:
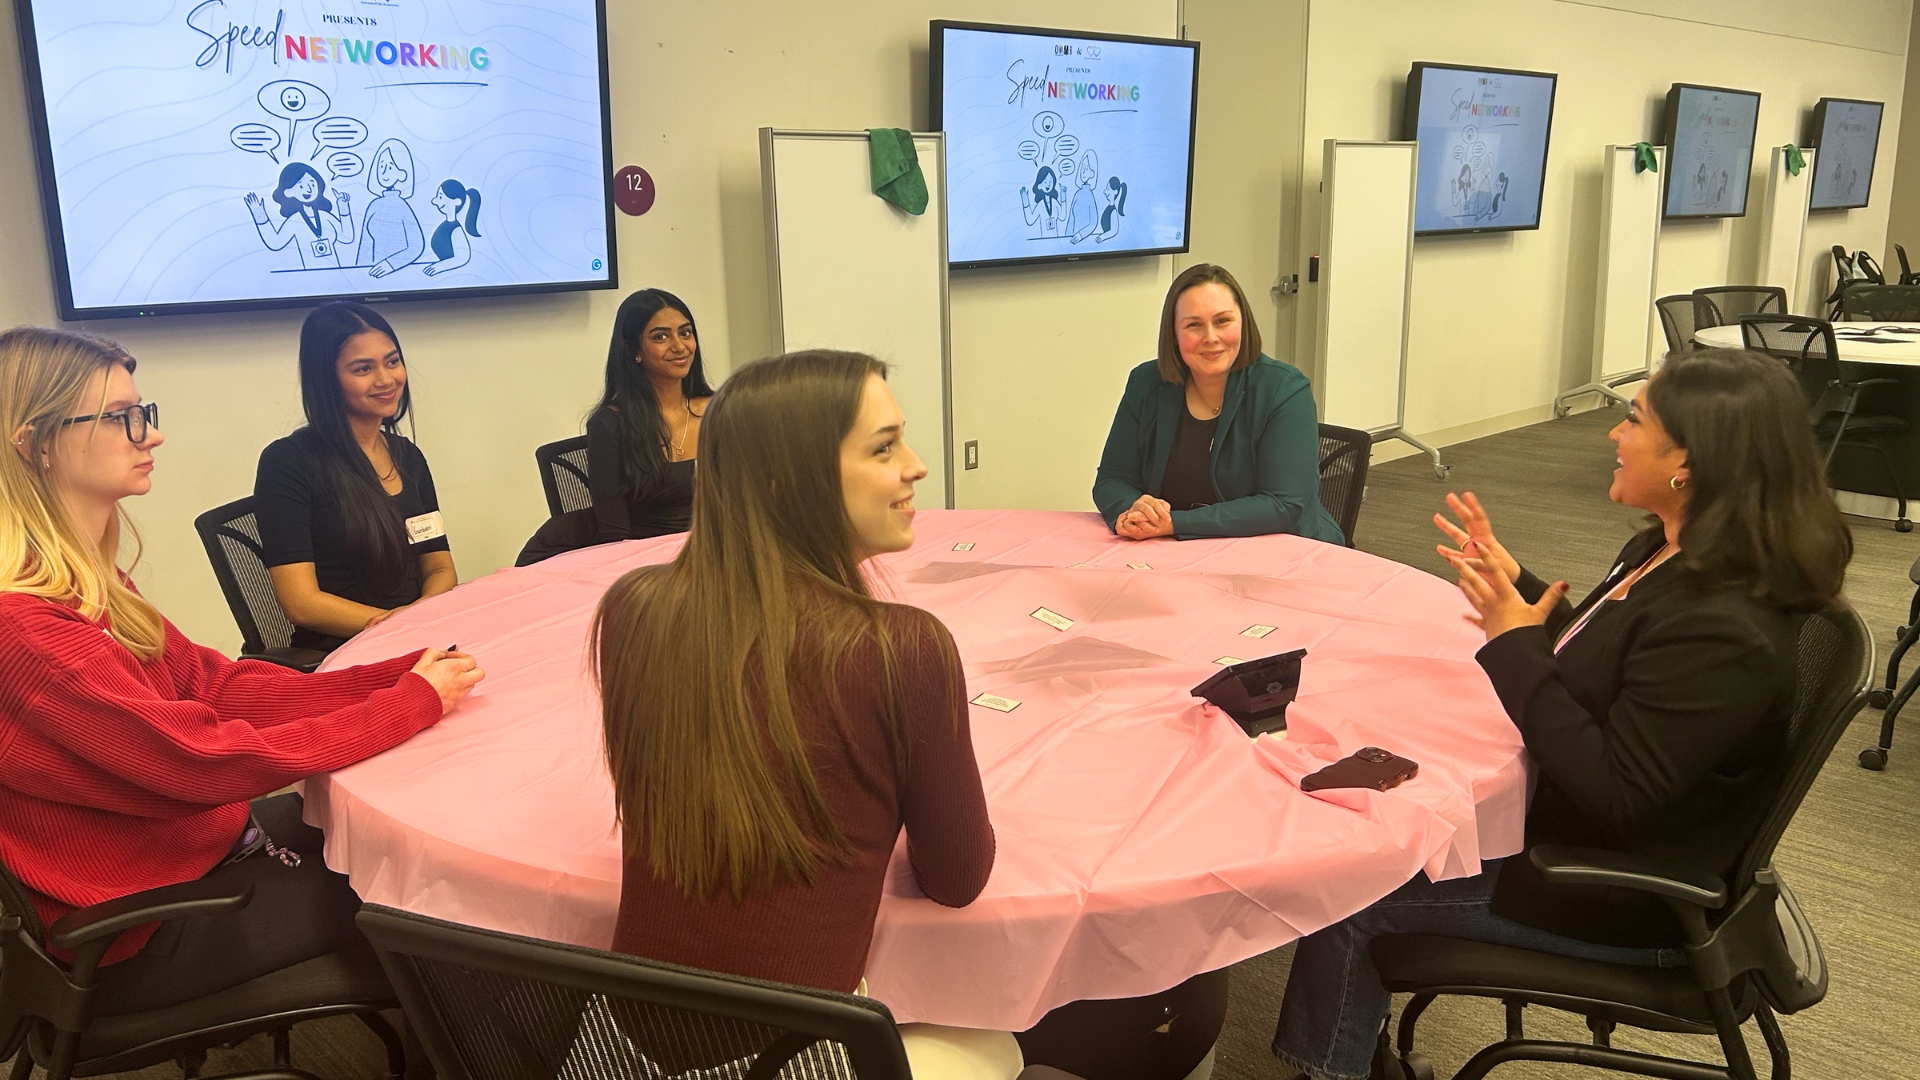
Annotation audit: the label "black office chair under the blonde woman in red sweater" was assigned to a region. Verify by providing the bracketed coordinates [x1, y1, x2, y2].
[0, 845, 407, 1080]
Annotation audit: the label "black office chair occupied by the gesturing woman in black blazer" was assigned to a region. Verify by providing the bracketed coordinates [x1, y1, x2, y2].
[1373, 603, 1874, 1080]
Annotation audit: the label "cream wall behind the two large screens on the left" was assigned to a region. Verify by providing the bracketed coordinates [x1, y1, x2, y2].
[0, 0, 1177, 651]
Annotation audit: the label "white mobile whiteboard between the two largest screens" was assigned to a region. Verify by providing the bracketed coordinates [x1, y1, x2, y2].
[760, 127, 954, 509]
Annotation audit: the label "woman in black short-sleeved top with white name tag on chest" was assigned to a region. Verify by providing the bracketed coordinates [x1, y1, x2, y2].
[253, 302, 457, 651]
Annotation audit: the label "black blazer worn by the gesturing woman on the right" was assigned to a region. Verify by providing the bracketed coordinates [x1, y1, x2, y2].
[1478, 532, 1797, 947]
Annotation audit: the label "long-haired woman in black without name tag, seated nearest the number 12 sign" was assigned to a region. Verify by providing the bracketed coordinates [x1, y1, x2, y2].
[515, 288, 714, 567]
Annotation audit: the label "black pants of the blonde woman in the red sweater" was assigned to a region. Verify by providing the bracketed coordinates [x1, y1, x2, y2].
[94, 794, 363, 1017]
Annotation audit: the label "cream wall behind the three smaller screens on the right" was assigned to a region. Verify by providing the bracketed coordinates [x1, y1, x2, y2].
[1296, 0, 1910, 442]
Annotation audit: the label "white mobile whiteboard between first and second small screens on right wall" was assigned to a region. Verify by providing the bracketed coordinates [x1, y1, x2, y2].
[1553, 144, 1667, 417]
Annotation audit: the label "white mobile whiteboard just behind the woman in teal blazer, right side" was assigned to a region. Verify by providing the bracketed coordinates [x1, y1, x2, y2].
[1313, 138, 1448, 480]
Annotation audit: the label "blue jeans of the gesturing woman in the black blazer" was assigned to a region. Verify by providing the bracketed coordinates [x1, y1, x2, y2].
[1273, 861, 1686, 1080]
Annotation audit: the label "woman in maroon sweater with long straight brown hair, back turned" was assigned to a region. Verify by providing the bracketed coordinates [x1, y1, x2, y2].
[593, 352, 1021, 1080]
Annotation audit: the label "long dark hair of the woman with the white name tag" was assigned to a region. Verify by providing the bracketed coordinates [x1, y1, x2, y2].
[300, 300, 413, 590]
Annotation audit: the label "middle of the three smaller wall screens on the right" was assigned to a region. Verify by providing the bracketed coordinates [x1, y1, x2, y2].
[1661, 83, 1761, 217]
